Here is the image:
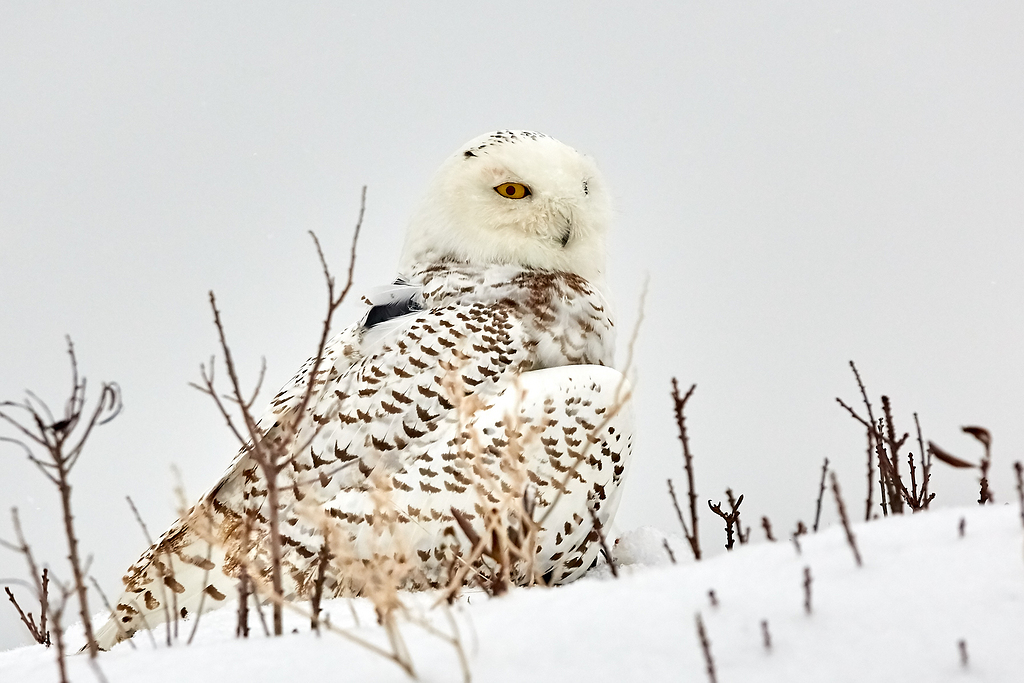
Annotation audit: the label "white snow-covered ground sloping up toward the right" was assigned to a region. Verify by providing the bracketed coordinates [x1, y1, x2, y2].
[0, 505, 1024, 683]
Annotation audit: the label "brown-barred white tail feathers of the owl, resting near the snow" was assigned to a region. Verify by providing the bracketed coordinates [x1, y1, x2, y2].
[96, 524, 238, 650]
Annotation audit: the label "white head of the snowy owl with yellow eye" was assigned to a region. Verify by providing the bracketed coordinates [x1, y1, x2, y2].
[401, 130, 611, 284]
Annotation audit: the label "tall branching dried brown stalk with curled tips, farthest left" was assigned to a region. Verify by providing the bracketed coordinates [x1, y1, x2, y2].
[0, 337, 121, 658]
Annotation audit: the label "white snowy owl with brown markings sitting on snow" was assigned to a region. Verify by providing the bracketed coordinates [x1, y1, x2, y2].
[97, 131, 633, 649]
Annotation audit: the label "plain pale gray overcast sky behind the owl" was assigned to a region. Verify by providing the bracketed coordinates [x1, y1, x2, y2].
[0, 0, 1024, 647]
